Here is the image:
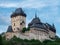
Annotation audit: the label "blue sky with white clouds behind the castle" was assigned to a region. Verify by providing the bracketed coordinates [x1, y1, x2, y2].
[0, 0, 60, 36]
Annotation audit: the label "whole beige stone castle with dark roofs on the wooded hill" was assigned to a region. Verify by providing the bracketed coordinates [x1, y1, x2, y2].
[5, 8, 56, 40]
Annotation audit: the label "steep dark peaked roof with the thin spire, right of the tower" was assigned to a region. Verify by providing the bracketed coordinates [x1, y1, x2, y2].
[28, 16, 46, 29]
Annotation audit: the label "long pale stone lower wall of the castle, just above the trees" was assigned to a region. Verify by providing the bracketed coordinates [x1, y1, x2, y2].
[6, 28, 55, 41]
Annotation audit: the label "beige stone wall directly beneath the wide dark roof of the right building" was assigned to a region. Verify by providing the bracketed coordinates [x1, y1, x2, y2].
[30, 28, 49, 40]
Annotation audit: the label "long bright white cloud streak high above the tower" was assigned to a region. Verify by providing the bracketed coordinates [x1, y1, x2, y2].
[0, 0, 46, 8]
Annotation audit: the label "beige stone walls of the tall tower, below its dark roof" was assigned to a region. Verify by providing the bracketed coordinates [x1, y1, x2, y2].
[11, 16, 26, 32]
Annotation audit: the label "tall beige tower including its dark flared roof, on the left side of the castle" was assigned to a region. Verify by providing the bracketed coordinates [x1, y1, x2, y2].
[11, 8, 26, 32]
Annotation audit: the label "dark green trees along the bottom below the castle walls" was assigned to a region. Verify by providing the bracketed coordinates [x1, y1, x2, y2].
[0, 35, 60, 45]
